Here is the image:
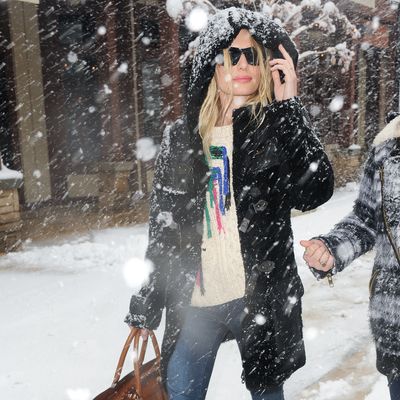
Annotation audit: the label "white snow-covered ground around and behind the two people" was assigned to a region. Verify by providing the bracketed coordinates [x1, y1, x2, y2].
[0, 186, 389, 400]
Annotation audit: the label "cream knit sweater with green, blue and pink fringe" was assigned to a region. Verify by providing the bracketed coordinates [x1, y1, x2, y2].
[191, 125, 245, 307]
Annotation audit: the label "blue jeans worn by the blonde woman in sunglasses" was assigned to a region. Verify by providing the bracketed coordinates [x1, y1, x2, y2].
[167, 299, 284, 400]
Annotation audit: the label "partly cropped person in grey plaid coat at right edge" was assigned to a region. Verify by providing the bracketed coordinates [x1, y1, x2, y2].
[300, 116, 400, 400]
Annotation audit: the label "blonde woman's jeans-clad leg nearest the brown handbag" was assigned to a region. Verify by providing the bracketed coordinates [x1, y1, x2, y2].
[167, 307, 227, 400]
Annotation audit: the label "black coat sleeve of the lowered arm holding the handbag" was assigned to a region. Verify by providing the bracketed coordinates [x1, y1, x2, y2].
[125, 120, 180, 329]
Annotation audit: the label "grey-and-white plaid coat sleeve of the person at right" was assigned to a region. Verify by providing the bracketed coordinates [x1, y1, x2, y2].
[313, 149, 380, 277]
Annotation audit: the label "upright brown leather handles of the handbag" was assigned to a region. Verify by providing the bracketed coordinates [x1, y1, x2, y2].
[111, 327, 161, 394]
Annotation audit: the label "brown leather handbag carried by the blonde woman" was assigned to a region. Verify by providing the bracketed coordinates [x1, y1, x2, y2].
[93, 328, 168, 400]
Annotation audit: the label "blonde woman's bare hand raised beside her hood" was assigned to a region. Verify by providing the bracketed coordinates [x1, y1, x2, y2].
[269, 44, 297, 101]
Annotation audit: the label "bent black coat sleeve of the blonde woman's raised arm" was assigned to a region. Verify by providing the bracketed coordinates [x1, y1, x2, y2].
[273, 97, 334, 211]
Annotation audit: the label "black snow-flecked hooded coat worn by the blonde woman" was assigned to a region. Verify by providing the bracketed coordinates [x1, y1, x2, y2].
[126, 10, 333, 390]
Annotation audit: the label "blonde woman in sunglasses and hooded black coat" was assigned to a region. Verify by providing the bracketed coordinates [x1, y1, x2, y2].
[127, 8, 333, 400]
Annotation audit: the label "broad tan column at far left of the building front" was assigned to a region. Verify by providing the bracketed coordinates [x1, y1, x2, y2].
[8, 1, 51, 203]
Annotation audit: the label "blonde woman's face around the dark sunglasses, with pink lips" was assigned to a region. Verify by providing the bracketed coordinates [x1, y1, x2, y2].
[216, 29, 260, 96]
